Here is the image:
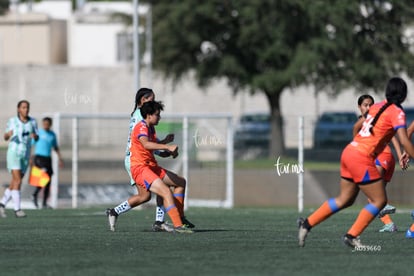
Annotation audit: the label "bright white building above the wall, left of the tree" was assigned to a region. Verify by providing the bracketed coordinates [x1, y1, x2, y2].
[68, 2, 148, 66]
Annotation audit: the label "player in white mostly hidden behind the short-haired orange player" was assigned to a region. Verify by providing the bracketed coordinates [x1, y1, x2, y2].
[125, 88, 174, 232]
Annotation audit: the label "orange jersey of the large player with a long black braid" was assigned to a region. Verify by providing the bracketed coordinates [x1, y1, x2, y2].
[351, 100, 406, 157]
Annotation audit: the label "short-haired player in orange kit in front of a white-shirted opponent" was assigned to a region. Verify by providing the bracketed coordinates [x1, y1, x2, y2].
[107, 101, 194, 233]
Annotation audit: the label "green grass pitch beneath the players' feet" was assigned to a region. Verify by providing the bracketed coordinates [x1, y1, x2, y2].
[0, 208, 414, 276]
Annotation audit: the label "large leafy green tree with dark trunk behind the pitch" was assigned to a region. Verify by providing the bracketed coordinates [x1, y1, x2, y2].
[151, 0, 414, 157]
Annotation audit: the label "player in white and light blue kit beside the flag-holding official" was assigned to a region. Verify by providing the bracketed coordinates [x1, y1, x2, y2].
[0, 100, 39, 218]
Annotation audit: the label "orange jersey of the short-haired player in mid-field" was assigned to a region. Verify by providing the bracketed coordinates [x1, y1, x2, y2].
[129, 120, 157, 168]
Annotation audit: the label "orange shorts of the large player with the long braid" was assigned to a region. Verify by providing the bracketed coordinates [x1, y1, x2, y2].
[341, 144, 381, 184]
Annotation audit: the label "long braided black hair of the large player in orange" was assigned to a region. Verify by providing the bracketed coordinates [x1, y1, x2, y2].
[370, 77, 407, 133]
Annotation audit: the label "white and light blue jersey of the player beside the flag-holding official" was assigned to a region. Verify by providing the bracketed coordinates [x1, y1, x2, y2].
[6, 116, 38, 157]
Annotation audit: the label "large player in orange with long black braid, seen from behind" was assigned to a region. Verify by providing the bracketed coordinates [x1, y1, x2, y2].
[298, 77, 414, 248]
